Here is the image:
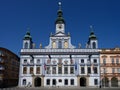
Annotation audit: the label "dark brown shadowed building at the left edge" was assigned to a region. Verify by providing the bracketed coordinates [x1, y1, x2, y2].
[0, 47, 20, 87]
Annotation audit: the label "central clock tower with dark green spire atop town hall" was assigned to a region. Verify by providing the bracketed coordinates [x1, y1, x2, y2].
[55, 2, 65, 33]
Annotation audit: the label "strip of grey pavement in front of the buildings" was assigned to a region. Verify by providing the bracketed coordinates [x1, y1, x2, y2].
[0, 87, 120, 90]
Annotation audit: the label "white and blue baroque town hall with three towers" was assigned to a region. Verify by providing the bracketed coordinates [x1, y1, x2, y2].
[19, 3, 100, 87]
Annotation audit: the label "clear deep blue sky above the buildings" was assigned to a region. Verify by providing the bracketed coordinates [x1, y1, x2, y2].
[0, 0, 120, 55]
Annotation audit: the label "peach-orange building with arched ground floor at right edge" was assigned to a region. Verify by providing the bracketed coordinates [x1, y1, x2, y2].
[100, 48, 120, 87]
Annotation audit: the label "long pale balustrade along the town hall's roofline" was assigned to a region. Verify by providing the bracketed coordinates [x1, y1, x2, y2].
[20, 49, 99, 55]
